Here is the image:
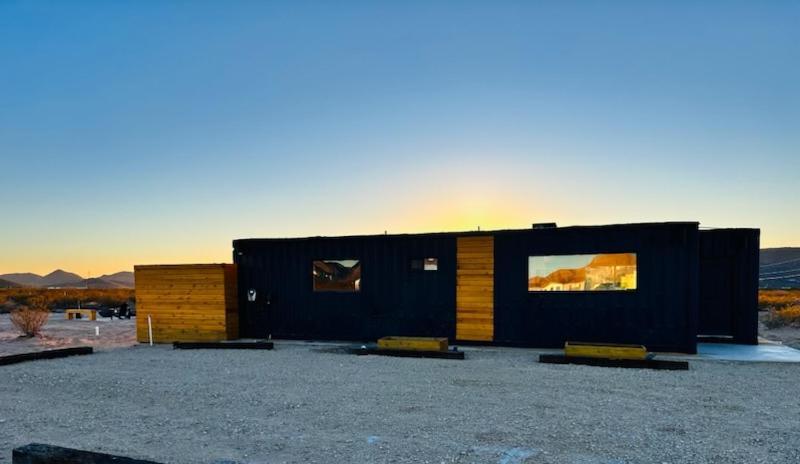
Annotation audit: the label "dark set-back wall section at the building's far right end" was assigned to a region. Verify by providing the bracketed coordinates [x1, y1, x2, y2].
[698, 229, 759, 344]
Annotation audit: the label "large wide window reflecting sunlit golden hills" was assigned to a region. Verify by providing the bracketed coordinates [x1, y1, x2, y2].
[528, 253, 636, 292]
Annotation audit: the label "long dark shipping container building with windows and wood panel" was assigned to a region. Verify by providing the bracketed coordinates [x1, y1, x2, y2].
[233, 222, 758, 353]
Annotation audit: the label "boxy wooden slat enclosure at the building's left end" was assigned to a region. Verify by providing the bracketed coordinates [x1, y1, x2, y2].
[134, 264, 239, 343]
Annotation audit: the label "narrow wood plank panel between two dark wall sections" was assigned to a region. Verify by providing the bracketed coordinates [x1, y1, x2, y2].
[456, 236, 494, 341]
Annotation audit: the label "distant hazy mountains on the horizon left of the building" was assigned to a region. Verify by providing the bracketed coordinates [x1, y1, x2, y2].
[0, 269, 134, 288]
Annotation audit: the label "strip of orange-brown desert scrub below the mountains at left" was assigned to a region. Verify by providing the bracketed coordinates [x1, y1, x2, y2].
[0, 288, 134, 313]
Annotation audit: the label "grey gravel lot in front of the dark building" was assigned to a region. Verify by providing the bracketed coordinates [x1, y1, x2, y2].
[0, 342, 800, 464]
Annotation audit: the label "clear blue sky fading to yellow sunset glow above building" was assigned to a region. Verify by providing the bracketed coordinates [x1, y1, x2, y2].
[0, 0, 800, 275]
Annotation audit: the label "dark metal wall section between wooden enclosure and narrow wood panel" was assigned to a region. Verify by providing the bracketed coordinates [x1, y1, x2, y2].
[234, 234, 456, 340]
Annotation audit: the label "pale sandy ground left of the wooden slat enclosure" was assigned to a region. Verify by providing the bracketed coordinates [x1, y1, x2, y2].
[0, 313, 136, 356]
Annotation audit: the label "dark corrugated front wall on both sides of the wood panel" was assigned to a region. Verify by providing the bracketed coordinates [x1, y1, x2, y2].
[234, 223, 716, 353]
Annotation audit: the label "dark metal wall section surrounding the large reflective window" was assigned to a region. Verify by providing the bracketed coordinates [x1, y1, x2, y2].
[495, 223, 698, 353]
